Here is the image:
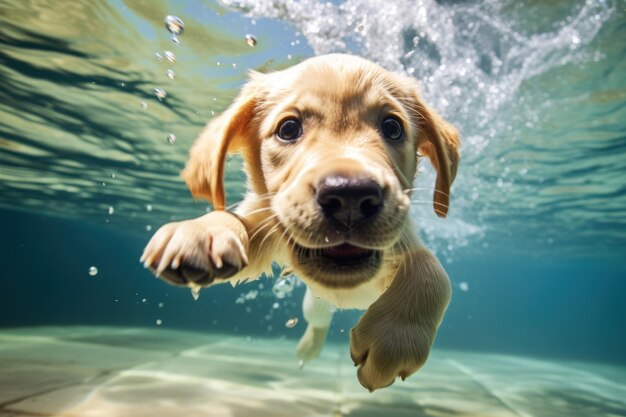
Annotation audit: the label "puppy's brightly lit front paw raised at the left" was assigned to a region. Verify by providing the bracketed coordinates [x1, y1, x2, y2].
[140, 218, 248, 286]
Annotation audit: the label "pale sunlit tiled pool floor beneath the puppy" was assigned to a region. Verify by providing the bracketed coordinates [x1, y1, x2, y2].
[0, 327, 626, 417]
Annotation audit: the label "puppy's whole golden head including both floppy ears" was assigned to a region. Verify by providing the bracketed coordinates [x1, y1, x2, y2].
[182, 55, 459, 287]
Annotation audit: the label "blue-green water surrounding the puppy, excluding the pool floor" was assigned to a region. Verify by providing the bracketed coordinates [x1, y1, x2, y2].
[0, 0, 626, 415]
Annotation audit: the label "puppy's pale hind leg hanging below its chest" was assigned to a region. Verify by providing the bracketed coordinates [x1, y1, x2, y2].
[296, 287, 335, 364]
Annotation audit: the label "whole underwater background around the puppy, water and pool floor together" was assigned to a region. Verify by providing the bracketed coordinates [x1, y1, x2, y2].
[0, 0, 626, 417]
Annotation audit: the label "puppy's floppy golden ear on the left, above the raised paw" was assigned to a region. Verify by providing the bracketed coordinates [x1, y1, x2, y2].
[180, 73, 260, 210]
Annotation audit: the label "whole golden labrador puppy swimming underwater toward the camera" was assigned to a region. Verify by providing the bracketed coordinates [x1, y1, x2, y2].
[142, 54, 459, 391]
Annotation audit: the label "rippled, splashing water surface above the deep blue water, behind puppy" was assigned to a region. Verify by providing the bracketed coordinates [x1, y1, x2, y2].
[0, 0, 626, 259]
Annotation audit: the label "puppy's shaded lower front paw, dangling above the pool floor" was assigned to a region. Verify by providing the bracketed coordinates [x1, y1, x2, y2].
[350, 305, 437, 392]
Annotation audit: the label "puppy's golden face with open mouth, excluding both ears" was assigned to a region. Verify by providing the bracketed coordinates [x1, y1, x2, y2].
[261, 61, 417, 286]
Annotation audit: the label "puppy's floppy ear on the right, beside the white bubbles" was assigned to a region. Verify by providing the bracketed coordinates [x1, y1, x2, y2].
[417, 100, 461, 217]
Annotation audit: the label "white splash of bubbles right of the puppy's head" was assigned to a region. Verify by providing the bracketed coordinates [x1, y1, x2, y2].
[221, 0, 616, 257]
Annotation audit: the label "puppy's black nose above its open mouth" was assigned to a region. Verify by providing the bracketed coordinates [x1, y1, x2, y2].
[317, 175, 383, 226]
